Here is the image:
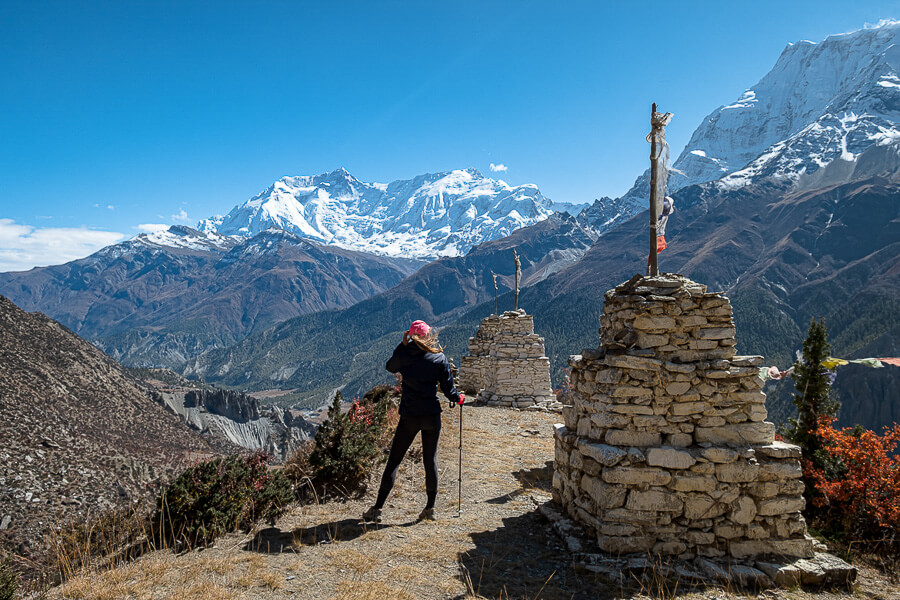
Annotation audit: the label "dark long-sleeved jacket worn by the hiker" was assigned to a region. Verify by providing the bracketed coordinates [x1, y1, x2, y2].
[385, 342, 459, 417]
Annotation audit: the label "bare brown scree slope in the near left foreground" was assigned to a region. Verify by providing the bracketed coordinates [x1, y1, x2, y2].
[0, 296, 212, 562]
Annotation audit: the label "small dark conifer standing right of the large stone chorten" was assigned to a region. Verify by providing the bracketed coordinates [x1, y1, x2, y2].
[785, 319, 840, 469]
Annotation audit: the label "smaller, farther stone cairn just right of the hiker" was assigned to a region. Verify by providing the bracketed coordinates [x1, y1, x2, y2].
[458, 308, 556, 408]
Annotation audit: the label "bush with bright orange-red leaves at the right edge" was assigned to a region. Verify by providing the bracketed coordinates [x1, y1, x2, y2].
[803, 417, 900, 541]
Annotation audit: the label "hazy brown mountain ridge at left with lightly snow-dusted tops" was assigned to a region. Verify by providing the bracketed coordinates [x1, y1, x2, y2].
[0, 226, 421, 366]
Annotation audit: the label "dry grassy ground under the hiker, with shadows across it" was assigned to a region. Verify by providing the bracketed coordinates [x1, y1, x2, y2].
[49, 407, 900, 600]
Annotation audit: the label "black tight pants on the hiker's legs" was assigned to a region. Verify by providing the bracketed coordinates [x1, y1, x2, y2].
[375, 414, 441, 509]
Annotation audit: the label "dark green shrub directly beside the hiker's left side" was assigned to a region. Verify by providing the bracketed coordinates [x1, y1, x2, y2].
[300, 386, 391, 497]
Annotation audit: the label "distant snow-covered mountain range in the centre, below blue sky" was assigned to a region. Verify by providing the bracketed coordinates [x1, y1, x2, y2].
[197, 169, 555, 259]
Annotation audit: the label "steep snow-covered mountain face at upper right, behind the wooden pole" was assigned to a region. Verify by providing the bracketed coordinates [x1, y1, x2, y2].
[585, 22, 900, 230]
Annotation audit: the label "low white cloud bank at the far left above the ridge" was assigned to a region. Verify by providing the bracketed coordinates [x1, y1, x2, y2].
[0, 218, 125, 273]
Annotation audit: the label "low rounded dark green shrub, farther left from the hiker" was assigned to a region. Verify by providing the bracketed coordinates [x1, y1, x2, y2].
[153, 452, 293, 547]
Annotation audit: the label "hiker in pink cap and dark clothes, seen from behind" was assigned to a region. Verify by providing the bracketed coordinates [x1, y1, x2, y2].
[363, 321, 465, 522]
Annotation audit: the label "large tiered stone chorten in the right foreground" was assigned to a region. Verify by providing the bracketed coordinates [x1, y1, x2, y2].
[553, 275, 813, 559]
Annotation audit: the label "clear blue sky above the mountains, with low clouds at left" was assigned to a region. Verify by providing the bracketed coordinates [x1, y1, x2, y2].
[0, 0, 900, 271]
